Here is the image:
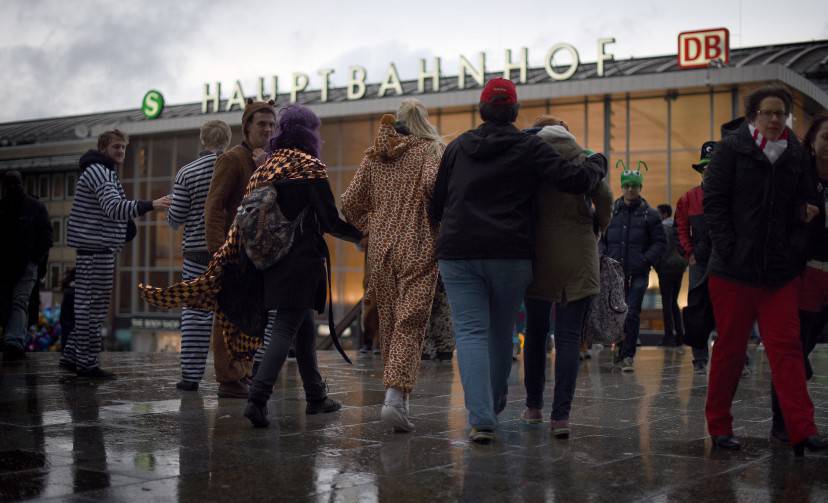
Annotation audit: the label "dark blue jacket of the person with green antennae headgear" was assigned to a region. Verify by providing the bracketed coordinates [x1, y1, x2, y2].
[601, 198, 667, 276]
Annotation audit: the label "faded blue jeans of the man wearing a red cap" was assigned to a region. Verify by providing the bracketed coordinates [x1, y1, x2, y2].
[439, 259, 532, 429]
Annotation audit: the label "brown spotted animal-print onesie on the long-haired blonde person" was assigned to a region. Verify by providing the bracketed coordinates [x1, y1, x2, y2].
[342, 115, 441, 393]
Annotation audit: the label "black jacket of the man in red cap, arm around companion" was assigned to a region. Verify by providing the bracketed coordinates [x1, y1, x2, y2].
[429, 122, 606, 259]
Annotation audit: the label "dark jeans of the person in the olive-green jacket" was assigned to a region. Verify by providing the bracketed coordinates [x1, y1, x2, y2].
[523, 297, 592, 421]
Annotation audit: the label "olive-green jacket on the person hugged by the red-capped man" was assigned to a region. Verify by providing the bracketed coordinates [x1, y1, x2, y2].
[526, 126, 612, 302]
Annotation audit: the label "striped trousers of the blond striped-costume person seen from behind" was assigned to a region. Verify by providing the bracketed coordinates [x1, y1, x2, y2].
[181, 258, 213, 382]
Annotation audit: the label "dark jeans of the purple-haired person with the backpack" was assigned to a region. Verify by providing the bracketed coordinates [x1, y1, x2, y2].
[248, 309, 327, 405]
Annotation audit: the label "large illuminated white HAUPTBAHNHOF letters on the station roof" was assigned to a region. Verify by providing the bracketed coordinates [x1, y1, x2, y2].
[201, 37, 615, 114]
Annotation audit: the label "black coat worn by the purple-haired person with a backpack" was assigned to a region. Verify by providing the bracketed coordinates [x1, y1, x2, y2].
[219, 180, 362, 332]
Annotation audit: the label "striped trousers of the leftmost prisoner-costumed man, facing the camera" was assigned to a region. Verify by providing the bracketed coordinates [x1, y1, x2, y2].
[61, 253, 115, 369]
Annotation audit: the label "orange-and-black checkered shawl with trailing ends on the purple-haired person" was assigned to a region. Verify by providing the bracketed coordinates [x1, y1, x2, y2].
[138, 149, 330, 361]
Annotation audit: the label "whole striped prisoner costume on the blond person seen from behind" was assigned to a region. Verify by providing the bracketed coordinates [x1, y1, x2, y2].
[167, 152, 218, 383]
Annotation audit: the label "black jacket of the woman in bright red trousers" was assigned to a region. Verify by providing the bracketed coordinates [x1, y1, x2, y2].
[704, 119, 811, 287]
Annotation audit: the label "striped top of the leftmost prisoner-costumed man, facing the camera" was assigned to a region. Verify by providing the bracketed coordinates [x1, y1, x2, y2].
[66, 164, 140, 252]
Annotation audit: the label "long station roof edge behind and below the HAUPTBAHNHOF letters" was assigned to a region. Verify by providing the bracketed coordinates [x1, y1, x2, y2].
[0, 40, 828, 151]
